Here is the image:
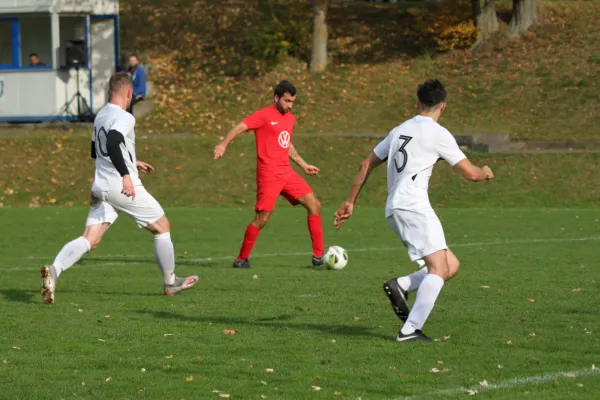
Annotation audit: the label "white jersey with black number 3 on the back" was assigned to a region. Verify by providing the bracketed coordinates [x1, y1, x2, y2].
[373, 115, 466, 217]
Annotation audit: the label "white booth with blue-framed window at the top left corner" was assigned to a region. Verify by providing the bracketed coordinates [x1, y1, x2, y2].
[0, 0, 119, 122]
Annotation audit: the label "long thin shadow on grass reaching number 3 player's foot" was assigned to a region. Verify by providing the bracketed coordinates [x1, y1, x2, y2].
[137, 310, 393, 341]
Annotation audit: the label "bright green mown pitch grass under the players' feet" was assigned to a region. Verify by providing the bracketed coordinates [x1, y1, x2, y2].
[0, 207, 600, 399]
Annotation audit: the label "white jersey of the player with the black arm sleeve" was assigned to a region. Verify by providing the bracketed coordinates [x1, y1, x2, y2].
[92, 103, 142, 191]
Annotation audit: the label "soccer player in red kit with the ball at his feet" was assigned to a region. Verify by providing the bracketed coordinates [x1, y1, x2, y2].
[214, 81, 323, 268]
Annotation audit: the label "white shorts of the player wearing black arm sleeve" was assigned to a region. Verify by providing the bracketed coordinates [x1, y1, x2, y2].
[85, 186, 165, 228]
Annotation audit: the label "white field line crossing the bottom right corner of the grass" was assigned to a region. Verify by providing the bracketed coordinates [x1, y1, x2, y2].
[392, 367, 600, 400]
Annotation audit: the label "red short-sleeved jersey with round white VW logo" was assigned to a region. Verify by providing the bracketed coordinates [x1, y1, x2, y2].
[243, 104, 296, 175]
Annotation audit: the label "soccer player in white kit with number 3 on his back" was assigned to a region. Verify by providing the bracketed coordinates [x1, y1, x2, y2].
[334, 80, 494, 342]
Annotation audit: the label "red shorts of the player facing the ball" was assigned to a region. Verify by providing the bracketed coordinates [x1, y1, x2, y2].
[255, 171, 313, 212]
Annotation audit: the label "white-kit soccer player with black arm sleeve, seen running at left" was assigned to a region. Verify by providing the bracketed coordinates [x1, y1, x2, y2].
[41, 73, 198, 304]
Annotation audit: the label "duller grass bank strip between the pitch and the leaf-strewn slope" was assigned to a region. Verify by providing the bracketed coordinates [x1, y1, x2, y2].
[0, 135, 600, 209]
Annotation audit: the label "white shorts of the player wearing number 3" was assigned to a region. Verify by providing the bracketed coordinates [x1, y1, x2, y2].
[387, 210, 448, 266]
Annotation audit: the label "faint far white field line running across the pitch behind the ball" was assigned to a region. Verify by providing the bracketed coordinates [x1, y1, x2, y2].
[10, 236, 600, 271]
